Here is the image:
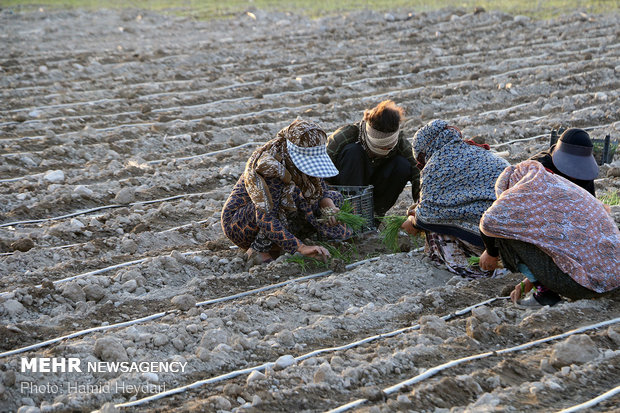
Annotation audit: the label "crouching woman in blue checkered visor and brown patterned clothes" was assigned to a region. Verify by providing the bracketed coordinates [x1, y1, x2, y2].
[222, 119, 352, 262]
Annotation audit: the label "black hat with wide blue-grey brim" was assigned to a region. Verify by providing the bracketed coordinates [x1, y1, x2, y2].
[551, 128, 598, 181]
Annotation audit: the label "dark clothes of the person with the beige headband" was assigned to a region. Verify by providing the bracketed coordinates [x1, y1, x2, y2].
[329, 143, 411, 216]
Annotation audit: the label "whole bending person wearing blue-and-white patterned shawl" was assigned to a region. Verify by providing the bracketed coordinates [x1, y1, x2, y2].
[402, 120, 508, 278]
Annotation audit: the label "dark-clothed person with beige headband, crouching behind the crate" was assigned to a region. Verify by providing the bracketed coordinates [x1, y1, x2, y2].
[327, 100, 420, 217]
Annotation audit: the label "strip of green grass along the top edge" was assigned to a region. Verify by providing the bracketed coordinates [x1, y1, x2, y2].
[0, 0, 620, 19]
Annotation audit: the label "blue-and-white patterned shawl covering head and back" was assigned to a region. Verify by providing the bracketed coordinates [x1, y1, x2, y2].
[413, 120, 508, 236]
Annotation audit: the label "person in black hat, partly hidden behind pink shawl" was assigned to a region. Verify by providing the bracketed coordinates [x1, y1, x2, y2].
[530, 128, 598, 196]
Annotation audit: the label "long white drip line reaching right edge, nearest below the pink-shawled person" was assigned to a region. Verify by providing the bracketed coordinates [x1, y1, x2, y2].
[327, 317, 620, 413]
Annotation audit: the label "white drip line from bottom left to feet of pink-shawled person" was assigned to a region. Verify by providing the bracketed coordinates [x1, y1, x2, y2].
[115, 294, 508, 408]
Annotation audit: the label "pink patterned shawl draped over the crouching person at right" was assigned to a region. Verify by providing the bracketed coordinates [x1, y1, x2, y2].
[480, 160, 620, 293]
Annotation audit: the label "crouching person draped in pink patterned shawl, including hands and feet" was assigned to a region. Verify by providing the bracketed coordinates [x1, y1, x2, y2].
[480, 160, 620, 307]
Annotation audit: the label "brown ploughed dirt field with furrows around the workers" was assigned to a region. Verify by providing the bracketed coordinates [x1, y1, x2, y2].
[0, 5, 620, 413]
